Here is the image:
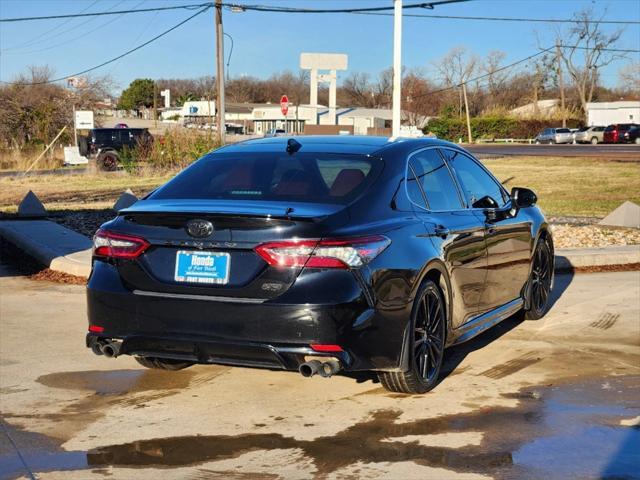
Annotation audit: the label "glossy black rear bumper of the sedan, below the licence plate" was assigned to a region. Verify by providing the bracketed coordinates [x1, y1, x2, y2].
[87, 265, 408, 370]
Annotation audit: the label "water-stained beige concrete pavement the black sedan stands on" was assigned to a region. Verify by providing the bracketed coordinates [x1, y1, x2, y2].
[0, 267, 640, 480]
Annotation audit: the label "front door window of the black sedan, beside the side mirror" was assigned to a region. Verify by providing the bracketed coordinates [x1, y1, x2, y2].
[444, 150, 509, 208]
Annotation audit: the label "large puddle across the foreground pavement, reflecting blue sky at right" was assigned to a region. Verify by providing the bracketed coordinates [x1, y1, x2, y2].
[0, 376, 640, 479]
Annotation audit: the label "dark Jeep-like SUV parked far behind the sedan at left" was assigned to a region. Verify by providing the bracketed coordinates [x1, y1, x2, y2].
[78, 128, 153, 171]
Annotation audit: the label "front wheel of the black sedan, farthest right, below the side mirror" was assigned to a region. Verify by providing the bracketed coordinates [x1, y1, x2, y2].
[525, 238, 554, 320]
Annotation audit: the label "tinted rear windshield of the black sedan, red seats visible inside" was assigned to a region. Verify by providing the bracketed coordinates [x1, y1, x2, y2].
[148, 152, 382, 204]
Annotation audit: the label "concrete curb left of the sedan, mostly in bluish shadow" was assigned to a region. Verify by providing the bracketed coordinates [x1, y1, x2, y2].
[0, 220, 91, 277]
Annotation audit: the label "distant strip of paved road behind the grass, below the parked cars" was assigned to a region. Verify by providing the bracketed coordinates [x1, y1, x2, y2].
[465, 144, 640, 162]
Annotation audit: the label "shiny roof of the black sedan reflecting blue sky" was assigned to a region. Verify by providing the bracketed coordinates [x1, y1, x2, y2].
[218, 135, 453, 155]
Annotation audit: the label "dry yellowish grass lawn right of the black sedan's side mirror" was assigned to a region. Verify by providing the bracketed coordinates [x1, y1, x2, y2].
[483, 157, 640, 217]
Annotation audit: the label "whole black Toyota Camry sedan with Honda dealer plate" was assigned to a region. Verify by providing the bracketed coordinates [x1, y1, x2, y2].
[87, 136, 554, 393]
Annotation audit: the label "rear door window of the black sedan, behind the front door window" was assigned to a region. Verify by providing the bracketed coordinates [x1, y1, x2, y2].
[407, 149, 464, 210]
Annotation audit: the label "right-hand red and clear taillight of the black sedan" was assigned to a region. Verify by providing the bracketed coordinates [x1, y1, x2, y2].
[256, 235, 391, 268]
